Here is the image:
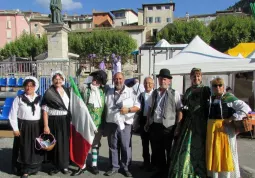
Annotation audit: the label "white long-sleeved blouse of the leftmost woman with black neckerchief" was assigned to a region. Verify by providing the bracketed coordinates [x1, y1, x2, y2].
[9, 93, 41, 131]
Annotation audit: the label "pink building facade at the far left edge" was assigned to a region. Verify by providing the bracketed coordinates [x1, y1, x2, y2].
[0, 10, 30, 48]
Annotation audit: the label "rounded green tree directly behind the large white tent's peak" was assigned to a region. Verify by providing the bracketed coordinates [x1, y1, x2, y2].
[157, 20, 211, 44]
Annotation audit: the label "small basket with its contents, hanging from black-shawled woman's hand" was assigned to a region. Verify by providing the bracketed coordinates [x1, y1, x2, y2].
[35, 133, 56, 151]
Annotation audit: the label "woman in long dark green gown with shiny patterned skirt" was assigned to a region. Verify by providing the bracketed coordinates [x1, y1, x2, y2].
[168, 68, 210, 178]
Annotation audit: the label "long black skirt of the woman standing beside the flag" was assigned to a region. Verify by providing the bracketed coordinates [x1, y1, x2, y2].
[47, 116, 70, 169]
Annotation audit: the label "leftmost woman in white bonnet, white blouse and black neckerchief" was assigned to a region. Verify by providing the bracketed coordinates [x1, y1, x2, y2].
[9, 76, 43, 178]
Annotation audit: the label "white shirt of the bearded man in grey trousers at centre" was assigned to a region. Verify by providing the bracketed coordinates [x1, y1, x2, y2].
[105, 86, 140, 129]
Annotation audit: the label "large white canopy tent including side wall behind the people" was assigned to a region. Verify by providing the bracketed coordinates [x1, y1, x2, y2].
[153, 36, 255, 96]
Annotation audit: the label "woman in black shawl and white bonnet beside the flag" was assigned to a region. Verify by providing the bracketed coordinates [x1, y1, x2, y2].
[42, 71, 71, 175]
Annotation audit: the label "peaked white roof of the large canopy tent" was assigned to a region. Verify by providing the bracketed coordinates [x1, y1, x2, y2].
[155, 36, 255, 75]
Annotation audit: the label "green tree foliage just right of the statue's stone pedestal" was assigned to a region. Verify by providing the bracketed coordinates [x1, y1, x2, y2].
[69, 30, 137, 63]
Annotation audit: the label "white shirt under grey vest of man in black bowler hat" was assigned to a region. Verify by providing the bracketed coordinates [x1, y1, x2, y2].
[148, 89, 182, 123]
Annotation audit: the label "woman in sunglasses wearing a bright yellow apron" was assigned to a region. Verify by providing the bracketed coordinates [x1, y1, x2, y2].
[206, 77, 251, 178]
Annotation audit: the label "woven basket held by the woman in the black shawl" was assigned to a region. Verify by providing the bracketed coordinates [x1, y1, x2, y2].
[35, 133, 56, 151]
